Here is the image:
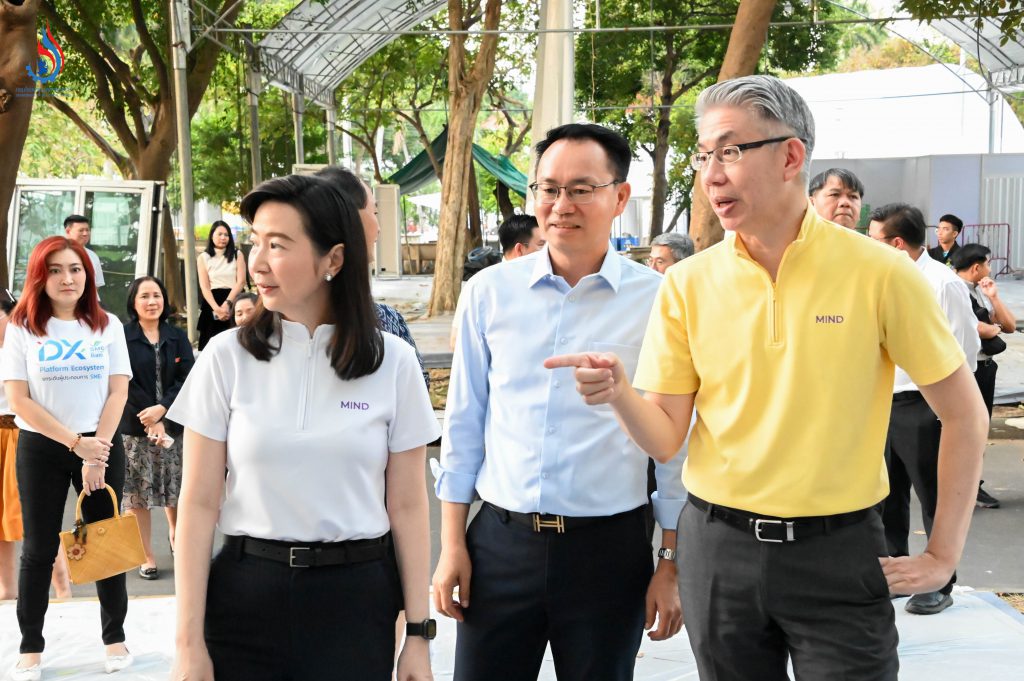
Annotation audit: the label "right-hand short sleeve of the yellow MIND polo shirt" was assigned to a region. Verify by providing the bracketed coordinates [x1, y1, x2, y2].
[879, 258, 965, 385]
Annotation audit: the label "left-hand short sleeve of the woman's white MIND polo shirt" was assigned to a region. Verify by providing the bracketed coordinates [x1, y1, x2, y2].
[167, 334, 238, 442]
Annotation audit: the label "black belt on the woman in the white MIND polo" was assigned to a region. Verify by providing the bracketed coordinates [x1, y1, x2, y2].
[224, 533, 391, 567]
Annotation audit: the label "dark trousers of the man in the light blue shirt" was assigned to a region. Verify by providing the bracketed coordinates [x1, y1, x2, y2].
[455, 505, 653, 681]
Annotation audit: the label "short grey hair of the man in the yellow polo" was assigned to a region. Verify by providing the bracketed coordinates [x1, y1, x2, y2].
[696, 76, 814, 183]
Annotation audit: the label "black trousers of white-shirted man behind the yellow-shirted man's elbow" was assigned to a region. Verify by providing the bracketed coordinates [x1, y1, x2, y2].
[882, 391, 956, 594]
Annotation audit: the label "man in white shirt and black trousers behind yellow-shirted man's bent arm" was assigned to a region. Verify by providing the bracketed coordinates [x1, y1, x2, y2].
[868, 204, 981, 614]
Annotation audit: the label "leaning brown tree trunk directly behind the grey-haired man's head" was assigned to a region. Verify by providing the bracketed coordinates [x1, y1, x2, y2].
[690, 0, 776, 251]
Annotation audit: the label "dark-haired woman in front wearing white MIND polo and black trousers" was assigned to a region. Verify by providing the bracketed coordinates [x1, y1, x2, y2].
[168, 175, 438, 681]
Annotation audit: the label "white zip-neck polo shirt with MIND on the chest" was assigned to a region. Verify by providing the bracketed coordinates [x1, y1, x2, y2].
[167, 322, 440, 542]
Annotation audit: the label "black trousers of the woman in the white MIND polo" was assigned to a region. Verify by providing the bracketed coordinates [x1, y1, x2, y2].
[205, 532, 401, 681]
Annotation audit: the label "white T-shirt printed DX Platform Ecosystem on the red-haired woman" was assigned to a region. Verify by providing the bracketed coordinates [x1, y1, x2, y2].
[0, 311, 132, 433]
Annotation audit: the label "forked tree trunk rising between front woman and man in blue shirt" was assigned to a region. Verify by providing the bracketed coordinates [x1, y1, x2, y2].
[427, 0, 502, 315]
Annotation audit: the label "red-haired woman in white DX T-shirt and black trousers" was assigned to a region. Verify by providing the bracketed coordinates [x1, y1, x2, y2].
[2, 237, 131, 681]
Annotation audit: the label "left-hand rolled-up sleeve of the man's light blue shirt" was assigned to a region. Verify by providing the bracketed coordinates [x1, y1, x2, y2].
[433, 282, 490, 504]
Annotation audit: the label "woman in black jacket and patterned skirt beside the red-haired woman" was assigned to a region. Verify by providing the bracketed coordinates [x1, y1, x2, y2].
[121, 276, 195, 580]
